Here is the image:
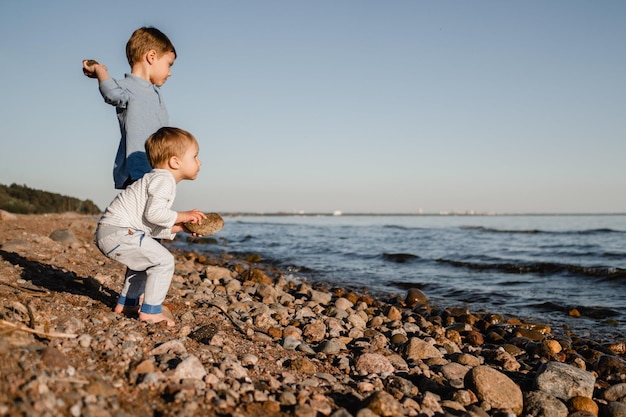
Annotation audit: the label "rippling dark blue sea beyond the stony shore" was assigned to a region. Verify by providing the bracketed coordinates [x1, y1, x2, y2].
[172, 214, 626, 342]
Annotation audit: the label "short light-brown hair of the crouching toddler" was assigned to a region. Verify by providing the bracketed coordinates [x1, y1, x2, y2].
[145, 127, 198, 168]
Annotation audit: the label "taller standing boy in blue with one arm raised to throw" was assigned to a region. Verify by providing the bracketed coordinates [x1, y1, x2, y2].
[83, 27, 176, 189]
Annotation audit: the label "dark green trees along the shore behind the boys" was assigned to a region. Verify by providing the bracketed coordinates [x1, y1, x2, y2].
[0, 184, 102, 214]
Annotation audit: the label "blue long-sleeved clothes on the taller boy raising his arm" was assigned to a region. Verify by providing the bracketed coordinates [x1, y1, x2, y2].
[100, 74, 169, 189]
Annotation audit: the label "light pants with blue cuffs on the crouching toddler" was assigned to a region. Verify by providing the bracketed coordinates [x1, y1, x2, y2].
[95, 225, 174, 314]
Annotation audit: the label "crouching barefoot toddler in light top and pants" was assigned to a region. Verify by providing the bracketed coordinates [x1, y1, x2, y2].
[95, 127, 206, 326]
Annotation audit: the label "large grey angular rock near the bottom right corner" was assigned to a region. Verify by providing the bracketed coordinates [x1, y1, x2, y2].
[535, 362, 596, 401]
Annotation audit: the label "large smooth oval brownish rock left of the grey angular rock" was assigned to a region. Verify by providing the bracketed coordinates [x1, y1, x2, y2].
[465, 365, 524, 415]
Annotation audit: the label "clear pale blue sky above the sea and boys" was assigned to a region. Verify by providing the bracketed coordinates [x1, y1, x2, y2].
[0, 0, 626, 213]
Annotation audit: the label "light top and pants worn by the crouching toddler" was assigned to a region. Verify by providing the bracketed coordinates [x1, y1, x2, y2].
[95, 169, 178, 314]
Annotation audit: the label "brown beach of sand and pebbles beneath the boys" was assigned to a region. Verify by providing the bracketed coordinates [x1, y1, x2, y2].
[0, 212, 626, 417]
